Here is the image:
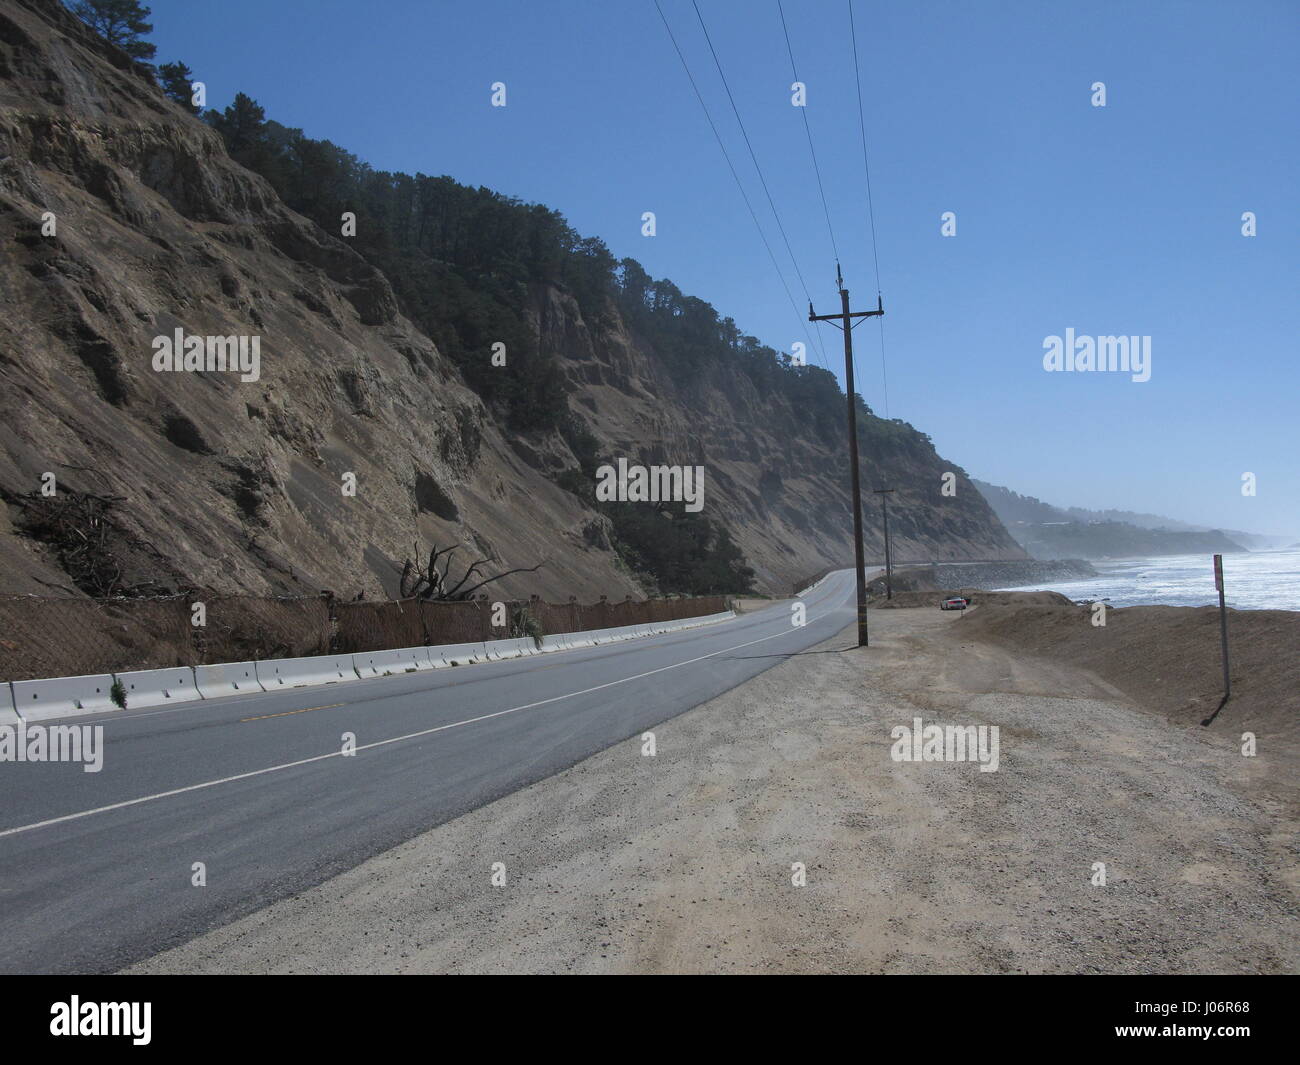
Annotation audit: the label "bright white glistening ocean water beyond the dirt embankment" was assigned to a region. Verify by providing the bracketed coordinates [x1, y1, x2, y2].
[993, 550, 1300, 610]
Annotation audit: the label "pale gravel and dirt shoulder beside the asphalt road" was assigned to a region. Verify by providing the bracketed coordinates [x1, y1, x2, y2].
[127, 609, 1300, 973]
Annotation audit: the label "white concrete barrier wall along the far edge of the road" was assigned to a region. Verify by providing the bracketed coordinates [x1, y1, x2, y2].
[0, 610, 736, 724]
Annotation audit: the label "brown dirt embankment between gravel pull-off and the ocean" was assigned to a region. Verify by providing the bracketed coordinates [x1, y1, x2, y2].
[962, 592, 1300, 750]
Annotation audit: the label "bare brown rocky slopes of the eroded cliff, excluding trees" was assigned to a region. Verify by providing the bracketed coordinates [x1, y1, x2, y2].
[0, 0, 1023, 598]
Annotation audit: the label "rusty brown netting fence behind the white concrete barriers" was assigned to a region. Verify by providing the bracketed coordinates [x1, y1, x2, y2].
[0, 596, 727, 680]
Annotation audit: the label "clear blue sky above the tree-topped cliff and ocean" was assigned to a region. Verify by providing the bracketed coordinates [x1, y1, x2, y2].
[137, 0, 1300, 537]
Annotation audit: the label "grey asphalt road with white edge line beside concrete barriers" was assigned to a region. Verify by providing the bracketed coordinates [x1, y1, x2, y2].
[0, 571, 853, 973]
